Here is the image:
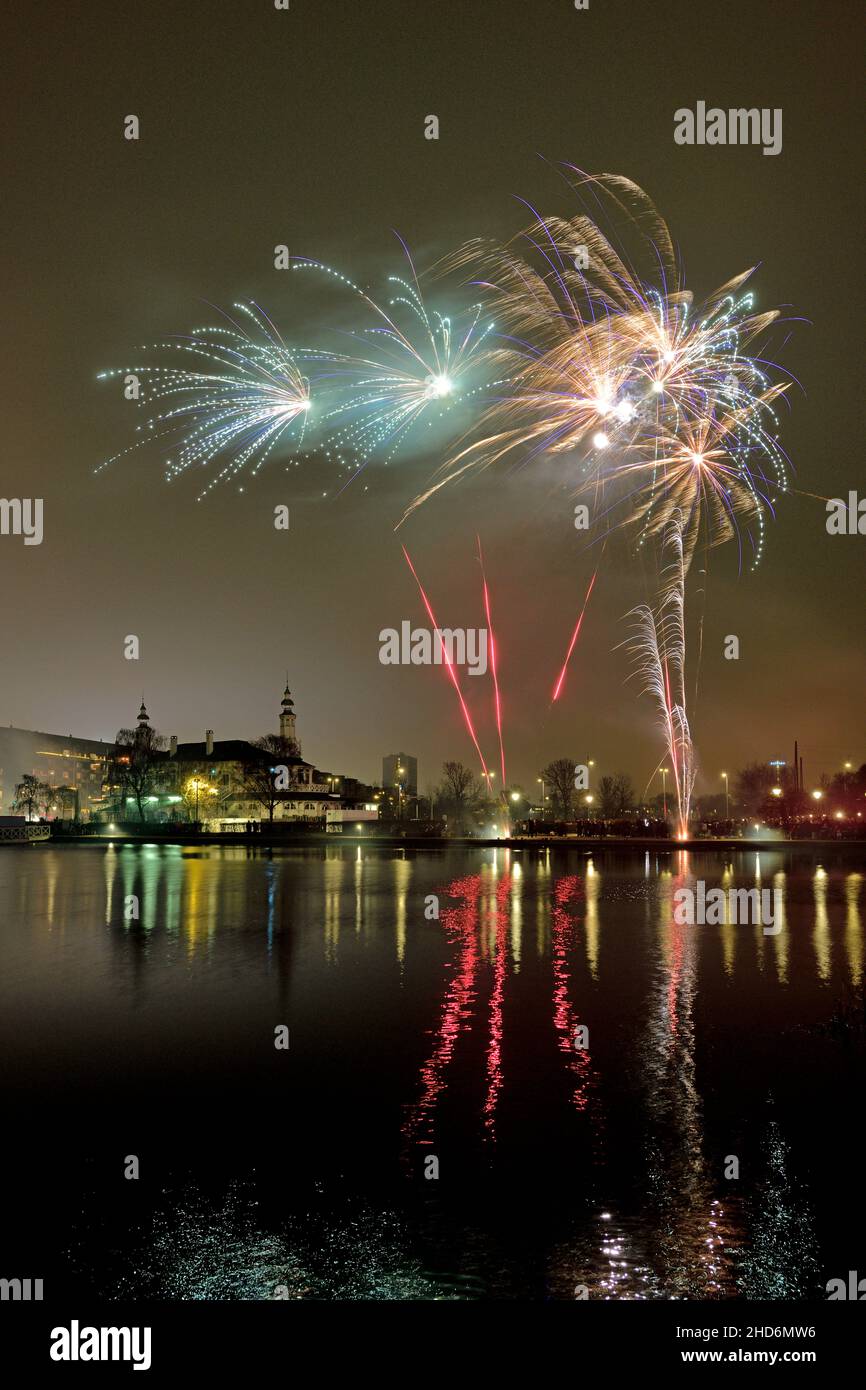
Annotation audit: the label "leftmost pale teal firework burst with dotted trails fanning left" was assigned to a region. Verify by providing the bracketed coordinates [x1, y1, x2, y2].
[97, 303, 310, 496]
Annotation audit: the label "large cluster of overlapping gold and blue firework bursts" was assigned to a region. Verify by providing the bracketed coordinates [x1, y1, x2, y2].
[407, 175, 787, 567]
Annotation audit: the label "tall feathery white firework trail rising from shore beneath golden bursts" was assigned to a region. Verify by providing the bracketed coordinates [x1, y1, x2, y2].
[626, 517, 695, 840]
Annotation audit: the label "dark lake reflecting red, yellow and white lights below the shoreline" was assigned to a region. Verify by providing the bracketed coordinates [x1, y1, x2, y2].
[0, 844, 865, 1300]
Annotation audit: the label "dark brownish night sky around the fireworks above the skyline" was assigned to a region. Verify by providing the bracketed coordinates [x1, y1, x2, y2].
[0, 0, 866, 790]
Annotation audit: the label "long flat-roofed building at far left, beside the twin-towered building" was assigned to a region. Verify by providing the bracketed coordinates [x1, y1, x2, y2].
[0, 724, 114, 820]
